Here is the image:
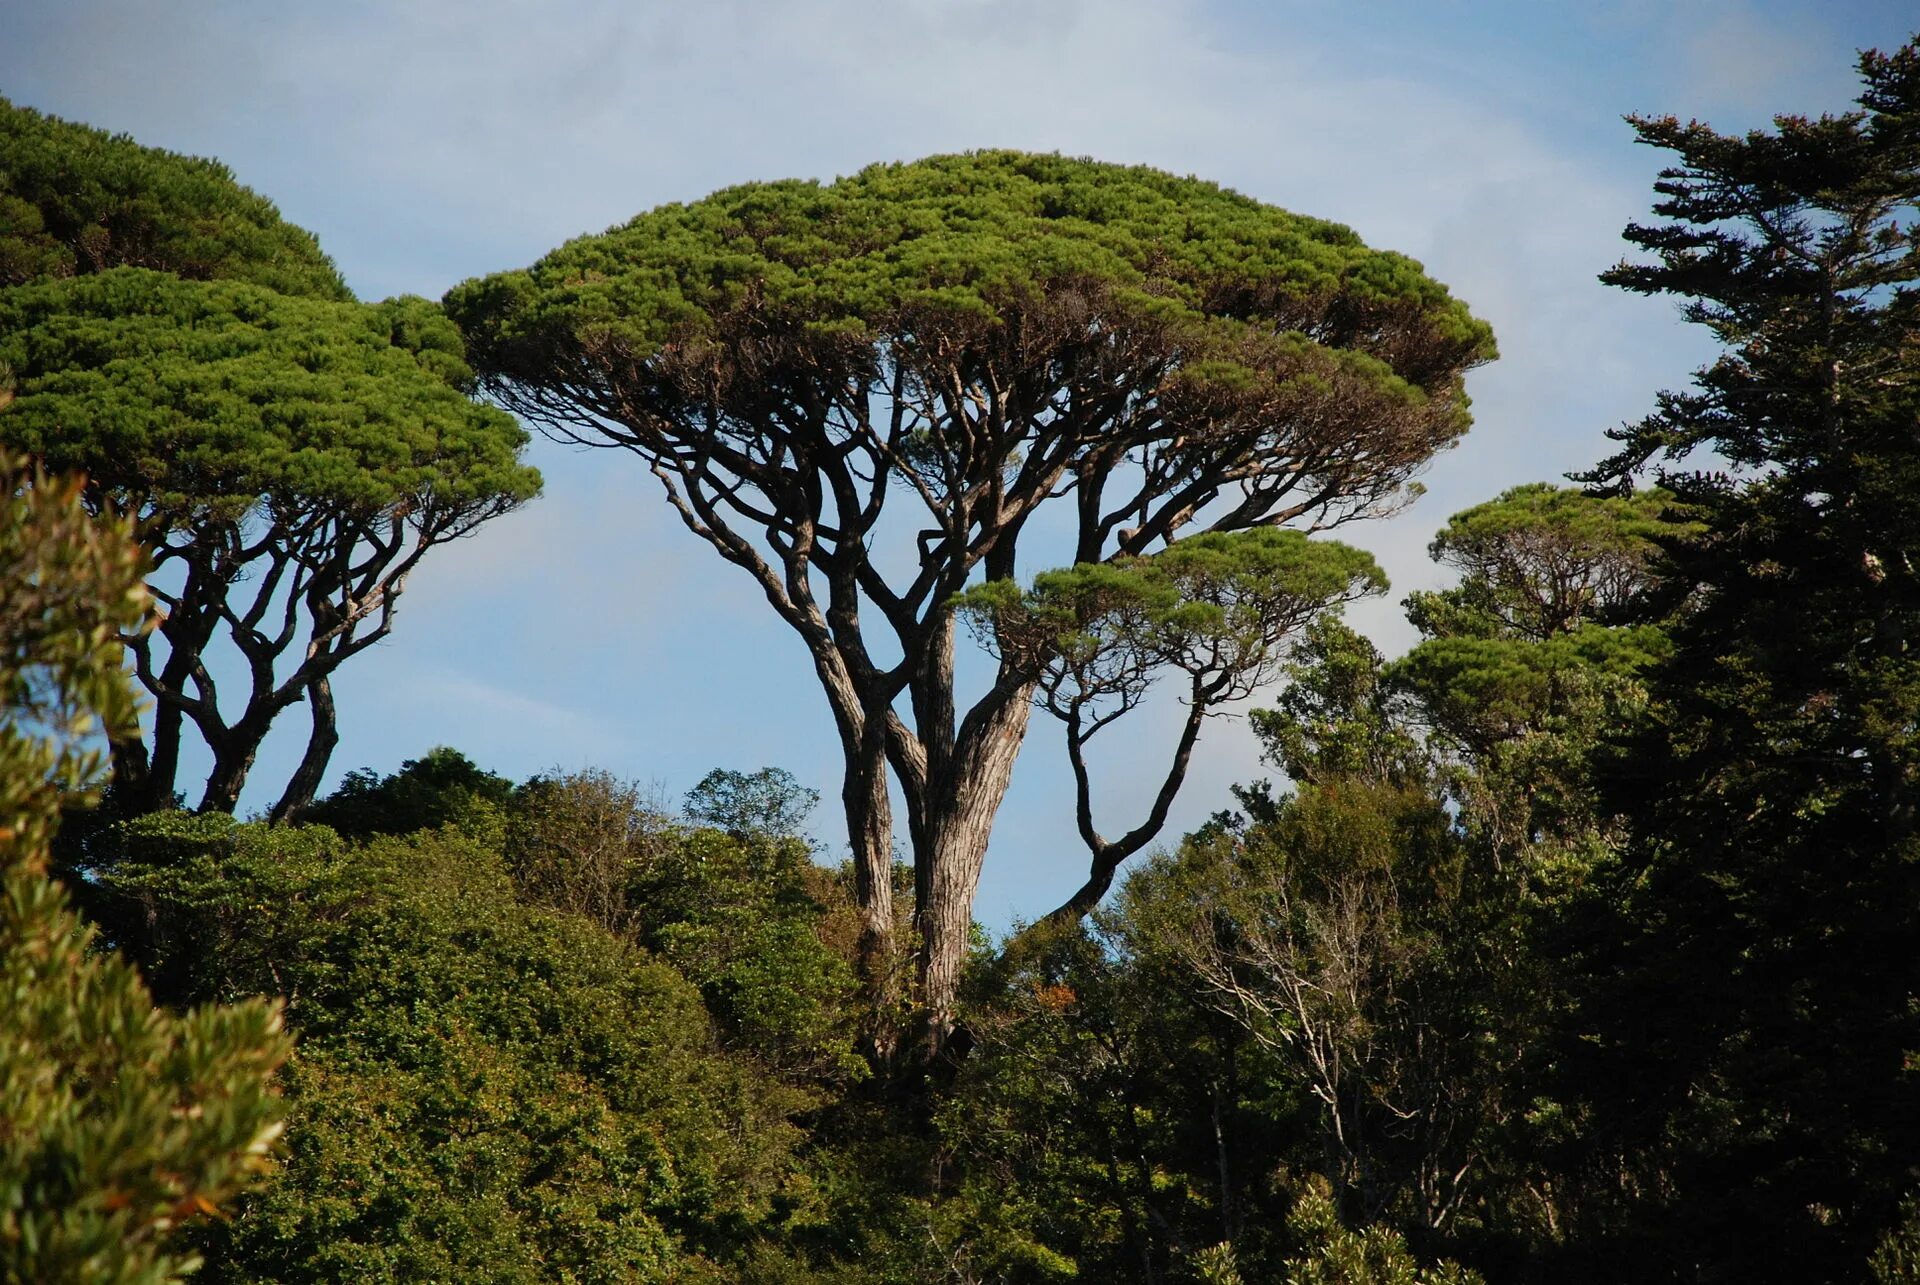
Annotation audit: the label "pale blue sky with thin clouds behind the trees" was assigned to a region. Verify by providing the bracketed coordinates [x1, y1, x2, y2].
[0, 0, 1920, 928]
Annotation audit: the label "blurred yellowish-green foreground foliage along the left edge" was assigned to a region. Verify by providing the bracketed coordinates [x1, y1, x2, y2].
[0, 459, 286, 1285]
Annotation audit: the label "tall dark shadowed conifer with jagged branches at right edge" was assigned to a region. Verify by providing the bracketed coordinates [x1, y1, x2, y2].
[1565, 44, 1920, 1281]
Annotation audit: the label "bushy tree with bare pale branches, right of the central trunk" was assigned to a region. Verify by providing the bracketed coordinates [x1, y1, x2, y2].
[1119, 780, 1517, 1231]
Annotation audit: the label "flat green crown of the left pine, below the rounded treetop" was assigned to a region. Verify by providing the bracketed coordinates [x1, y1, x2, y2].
[0, 269, 540, 517]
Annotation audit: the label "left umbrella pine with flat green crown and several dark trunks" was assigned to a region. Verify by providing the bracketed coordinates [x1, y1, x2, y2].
[0, 267, 540, 816]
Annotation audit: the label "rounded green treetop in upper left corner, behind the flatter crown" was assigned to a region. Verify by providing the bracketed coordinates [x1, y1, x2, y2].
[0, 98, 351, 300]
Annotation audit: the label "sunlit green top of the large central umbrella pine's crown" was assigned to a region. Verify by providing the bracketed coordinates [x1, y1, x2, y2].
[447, 152, 1494, 426]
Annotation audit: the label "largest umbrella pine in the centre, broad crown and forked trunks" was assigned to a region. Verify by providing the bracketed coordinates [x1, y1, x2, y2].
[447, 152, 1492, 1039]
